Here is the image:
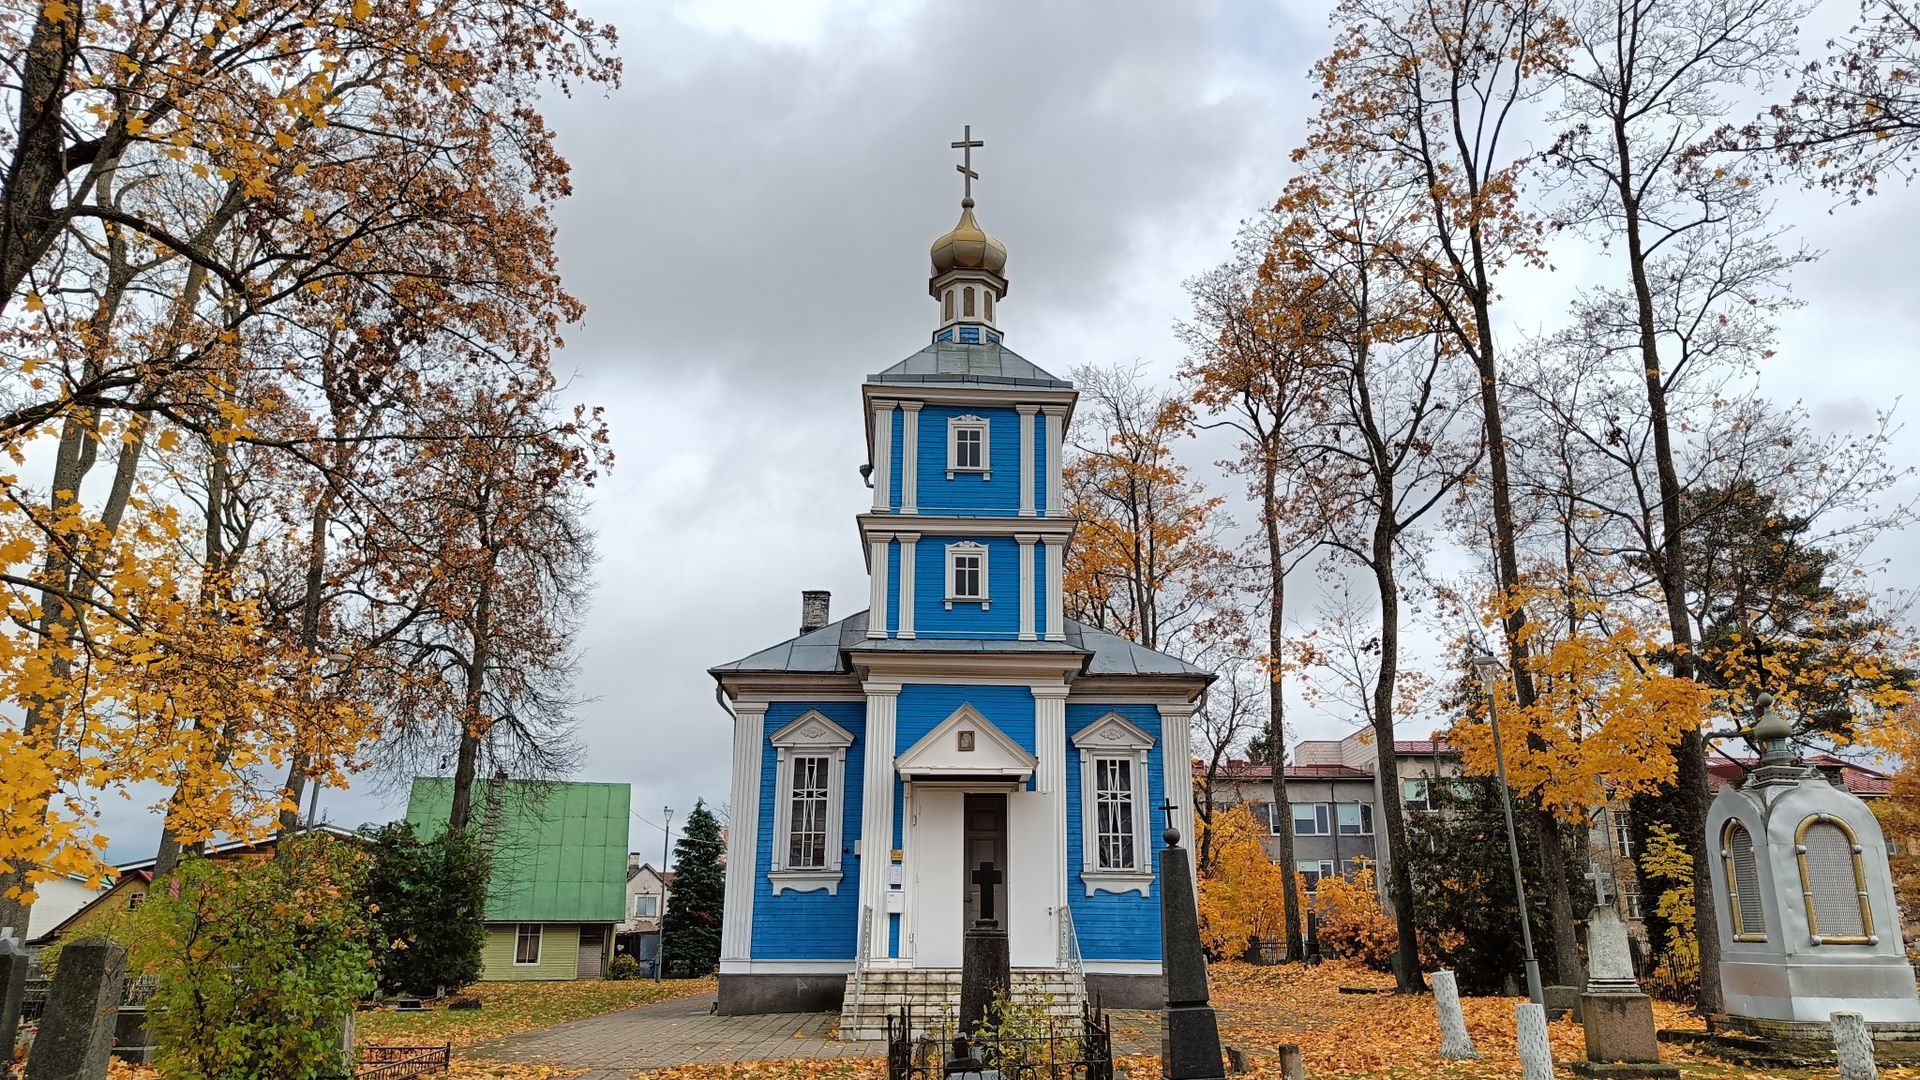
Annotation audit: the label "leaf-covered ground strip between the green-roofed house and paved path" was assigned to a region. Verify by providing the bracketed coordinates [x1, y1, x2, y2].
[353, 978, 716, 1045]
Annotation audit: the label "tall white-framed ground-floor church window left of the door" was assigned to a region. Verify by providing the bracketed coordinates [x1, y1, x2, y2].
[768, 711, 852, 896]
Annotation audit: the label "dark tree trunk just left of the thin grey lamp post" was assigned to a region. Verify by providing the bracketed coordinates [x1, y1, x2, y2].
[1373, 491, 1427, 994]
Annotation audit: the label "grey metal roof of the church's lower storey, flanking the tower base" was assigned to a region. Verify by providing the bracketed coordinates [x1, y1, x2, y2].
[708, 611, 1213, 678]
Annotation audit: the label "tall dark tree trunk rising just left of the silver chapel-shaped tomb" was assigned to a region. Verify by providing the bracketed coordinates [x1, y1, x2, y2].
[1613, 117, 1722, 1013]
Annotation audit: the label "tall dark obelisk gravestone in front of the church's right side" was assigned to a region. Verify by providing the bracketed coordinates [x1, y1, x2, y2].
[1160, 814, 1225, 1080]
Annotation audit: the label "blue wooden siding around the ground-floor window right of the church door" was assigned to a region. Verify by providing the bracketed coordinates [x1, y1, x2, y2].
[1068, 705, 1159, 961]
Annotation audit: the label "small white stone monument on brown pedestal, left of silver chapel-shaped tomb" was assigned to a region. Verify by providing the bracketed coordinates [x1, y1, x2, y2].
[1569, 901, 1680, 1080]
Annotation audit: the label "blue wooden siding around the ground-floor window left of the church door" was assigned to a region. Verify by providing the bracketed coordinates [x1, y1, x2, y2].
[753, 701, 866, 961]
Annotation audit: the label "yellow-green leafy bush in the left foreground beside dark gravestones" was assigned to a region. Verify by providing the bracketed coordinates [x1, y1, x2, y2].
[134, 834, 374, 1080]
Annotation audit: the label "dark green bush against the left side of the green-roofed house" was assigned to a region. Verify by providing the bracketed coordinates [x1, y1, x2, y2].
[365, 822, 490, 997]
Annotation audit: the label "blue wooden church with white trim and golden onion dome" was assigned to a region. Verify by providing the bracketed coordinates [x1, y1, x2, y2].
[712, 136, 1212, 1038]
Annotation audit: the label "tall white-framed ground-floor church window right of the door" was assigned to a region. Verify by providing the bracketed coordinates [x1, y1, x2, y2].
[1073, 713, 1154, 896]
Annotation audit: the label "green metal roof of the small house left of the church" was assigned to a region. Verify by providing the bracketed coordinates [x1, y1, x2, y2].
[407, 776, 632, 922]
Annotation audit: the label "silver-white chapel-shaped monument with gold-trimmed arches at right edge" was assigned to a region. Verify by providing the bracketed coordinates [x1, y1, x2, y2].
[1707, 694, 1920, 1042]
